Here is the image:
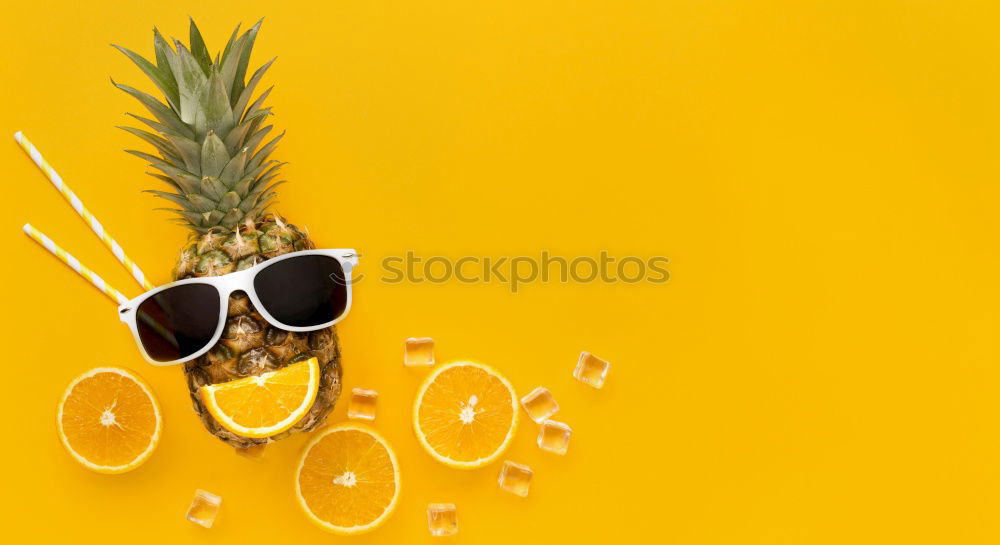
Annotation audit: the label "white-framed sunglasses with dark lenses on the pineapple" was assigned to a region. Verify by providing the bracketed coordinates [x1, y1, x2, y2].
[118, 249, 358, 365]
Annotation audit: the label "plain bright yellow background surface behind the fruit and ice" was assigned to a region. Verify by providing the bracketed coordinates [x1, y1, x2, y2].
[0, 0, 1000, 544]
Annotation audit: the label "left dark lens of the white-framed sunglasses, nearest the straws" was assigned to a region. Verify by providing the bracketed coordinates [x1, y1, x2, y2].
[135, 284, 219, 361]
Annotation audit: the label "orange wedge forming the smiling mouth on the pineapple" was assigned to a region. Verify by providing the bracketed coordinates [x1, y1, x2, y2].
[198, 358, 319, 437]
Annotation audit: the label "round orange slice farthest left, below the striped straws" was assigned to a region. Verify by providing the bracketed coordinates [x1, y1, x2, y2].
[56, 367, 163, 473]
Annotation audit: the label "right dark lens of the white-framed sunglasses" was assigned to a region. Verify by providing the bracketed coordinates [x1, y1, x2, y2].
[253, 255, 347, 327]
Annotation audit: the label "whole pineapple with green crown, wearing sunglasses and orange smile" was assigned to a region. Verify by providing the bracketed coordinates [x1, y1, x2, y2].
[112, 19, 341, 450]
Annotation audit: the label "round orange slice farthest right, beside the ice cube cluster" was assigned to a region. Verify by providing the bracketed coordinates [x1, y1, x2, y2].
[413, 361, 517, 469]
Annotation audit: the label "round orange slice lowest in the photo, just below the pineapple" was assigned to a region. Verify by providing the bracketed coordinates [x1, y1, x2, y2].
[295, 424, 399, 535]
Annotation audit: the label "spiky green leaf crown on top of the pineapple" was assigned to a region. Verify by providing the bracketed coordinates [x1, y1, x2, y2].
[111, 19, 284, 233]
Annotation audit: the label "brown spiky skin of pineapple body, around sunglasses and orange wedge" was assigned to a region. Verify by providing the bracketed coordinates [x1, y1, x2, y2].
[173, 216, 342, 448]
